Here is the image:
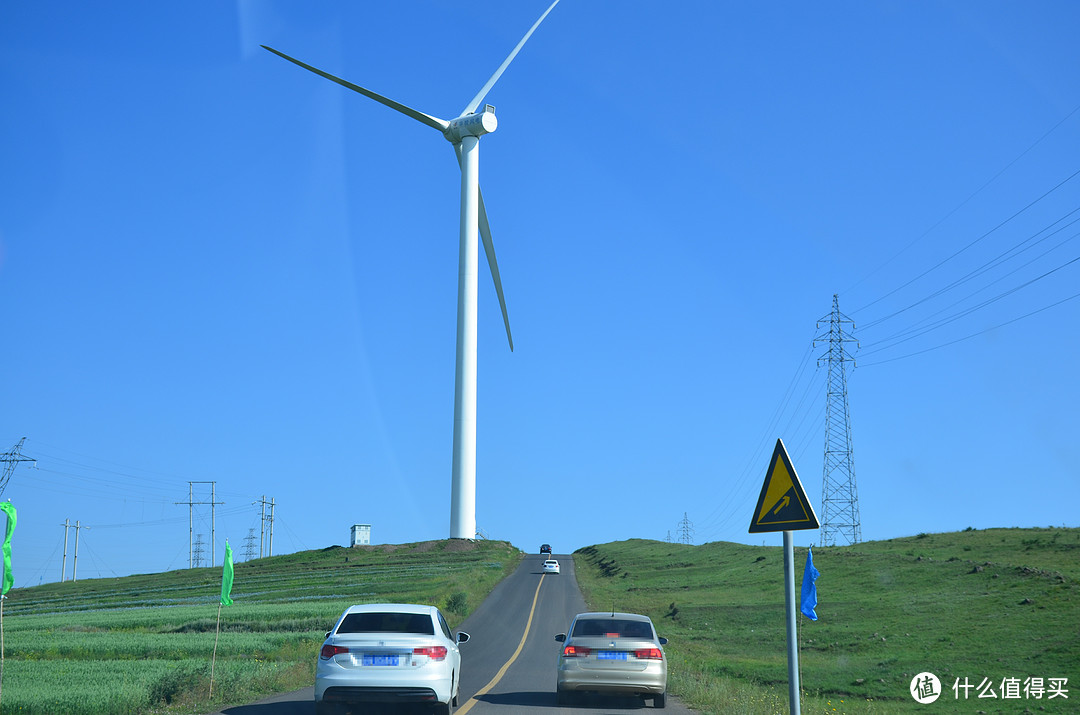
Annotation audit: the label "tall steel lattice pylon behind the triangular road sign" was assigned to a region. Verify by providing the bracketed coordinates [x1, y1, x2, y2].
[813, 295, 862, 547]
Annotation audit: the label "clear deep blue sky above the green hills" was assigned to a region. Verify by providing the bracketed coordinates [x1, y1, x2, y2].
[0, 0, 1080, 585]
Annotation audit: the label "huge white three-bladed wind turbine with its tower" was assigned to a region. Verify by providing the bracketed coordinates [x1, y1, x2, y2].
[262, 0, 558, 539]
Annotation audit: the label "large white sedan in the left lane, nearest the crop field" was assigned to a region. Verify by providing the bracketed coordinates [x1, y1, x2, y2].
[315, 604, 469, 715]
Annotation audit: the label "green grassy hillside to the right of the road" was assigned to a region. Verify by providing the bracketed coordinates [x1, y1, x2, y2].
[575, 528, 1080, 715]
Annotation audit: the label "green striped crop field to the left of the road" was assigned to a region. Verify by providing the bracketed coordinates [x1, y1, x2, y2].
[0, 541, 522, 715]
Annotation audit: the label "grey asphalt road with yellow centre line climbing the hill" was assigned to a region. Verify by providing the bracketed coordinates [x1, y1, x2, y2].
[212, 554, 692, 715]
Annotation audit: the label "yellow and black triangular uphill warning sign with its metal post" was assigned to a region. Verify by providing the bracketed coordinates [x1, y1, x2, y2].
[750, 440, 820, 715]
